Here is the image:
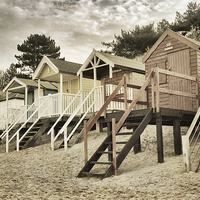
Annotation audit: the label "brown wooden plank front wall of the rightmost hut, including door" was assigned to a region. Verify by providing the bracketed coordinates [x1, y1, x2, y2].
[145, 35, 200, 110]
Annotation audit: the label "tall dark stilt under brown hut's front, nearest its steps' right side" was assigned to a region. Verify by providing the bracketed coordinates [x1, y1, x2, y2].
[156, 113, 164, 163]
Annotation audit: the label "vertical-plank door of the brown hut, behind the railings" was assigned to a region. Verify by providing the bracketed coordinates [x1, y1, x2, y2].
[168, 49, 192, 110]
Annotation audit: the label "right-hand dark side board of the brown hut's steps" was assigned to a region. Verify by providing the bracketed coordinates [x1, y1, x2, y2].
[103, 108, 153, 178]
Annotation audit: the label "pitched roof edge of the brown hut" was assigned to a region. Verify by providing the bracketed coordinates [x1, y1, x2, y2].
[142, 28, 200, 63]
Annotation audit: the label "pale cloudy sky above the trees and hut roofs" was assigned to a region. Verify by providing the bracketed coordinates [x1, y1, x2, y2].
[0, 0, 200, 71]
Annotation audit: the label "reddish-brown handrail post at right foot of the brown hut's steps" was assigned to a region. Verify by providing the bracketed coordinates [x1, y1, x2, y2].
[112, 118, 117, 175]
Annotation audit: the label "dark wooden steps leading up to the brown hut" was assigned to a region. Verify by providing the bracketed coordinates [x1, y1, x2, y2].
[78, 109, 153, 178]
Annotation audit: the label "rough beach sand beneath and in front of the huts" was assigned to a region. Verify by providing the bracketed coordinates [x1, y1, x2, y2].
[0, 126, 200, 200]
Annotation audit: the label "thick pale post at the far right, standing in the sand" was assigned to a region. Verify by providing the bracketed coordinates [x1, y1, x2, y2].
[182, 135, 191, 172]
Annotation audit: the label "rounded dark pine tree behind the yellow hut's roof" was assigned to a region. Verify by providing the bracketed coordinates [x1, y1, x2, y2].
[15, 34, 60, 73]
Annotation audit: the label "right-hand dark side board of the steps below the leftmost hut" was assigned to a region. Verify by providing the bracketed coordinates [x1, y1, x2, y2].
[21, 120, 50, 149]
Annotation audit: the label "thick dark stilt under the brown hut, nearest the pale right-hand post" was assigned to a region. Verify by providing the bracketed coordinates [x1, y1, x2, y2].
[173, 118, 182, 155]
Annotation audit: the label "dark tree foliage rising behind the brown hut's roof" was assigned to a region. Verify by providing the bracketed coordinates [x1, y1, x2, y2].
[102, 2, 200, 59]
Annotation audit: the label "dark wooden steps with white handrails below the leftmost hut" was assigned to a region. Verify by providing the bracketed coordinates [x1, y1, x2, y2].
[19, 120, 50, 150]
